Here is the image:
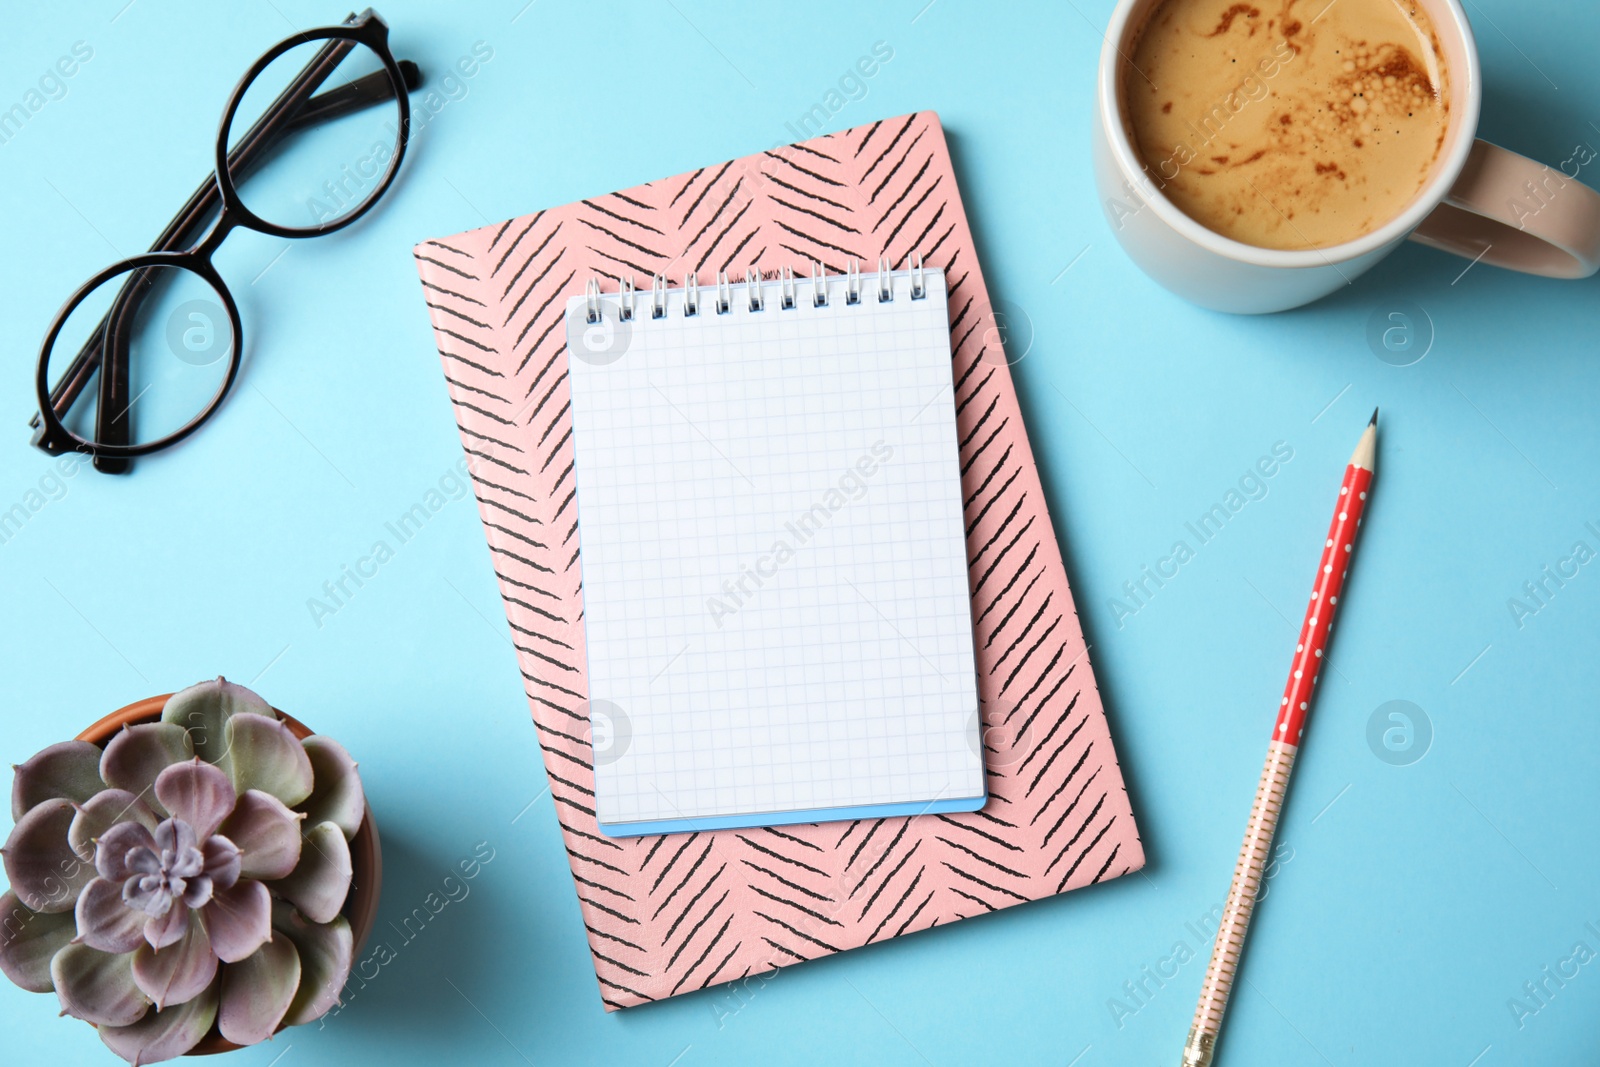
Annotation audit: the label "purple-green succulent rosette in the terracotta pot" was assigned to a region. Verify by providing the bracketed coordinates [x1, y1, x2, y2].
[0, 678, 366, 1064]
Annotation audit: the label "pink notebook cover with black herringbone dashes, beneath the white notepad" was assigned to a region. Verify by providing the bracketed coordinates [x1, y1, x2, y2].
[414, 112, 1144, 1011]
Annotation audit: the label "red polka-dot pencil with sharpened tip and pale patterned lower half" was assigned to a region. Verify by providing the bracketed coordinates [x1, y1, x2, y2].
[1182, 410, 1378, 1067]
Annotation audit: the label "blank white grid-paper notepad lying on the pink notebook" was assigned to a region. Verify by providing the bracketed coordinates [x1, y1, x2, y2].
[552, 270, 986, 837]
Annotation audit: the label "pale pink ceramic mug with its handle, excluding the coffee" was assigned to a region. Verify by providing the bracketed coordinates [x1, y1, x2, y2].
[1094, 0, 1600, 314]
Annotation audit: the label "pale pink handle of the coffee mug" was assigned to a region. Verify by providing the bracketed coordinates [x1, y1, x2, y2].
[1411, 141, 1600, 278]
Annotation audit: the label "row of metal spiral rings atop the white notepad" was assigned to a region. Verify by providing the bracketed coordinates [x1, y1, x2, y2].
[584, 253, 928, 325]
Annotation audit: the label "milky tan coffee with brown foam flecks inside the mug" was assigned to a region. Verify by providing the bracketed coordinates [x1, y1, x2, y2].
[1122, 0, 1450, 250]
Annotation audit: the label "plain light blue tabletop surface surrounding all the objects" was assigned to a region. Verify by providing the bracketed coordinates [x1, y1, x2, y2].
[0, 0, 1600, 1067]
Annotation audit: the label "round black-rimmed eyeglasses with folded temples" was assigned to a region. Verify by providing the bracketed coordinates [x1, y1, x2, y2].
[30, 8, 421, 474]
